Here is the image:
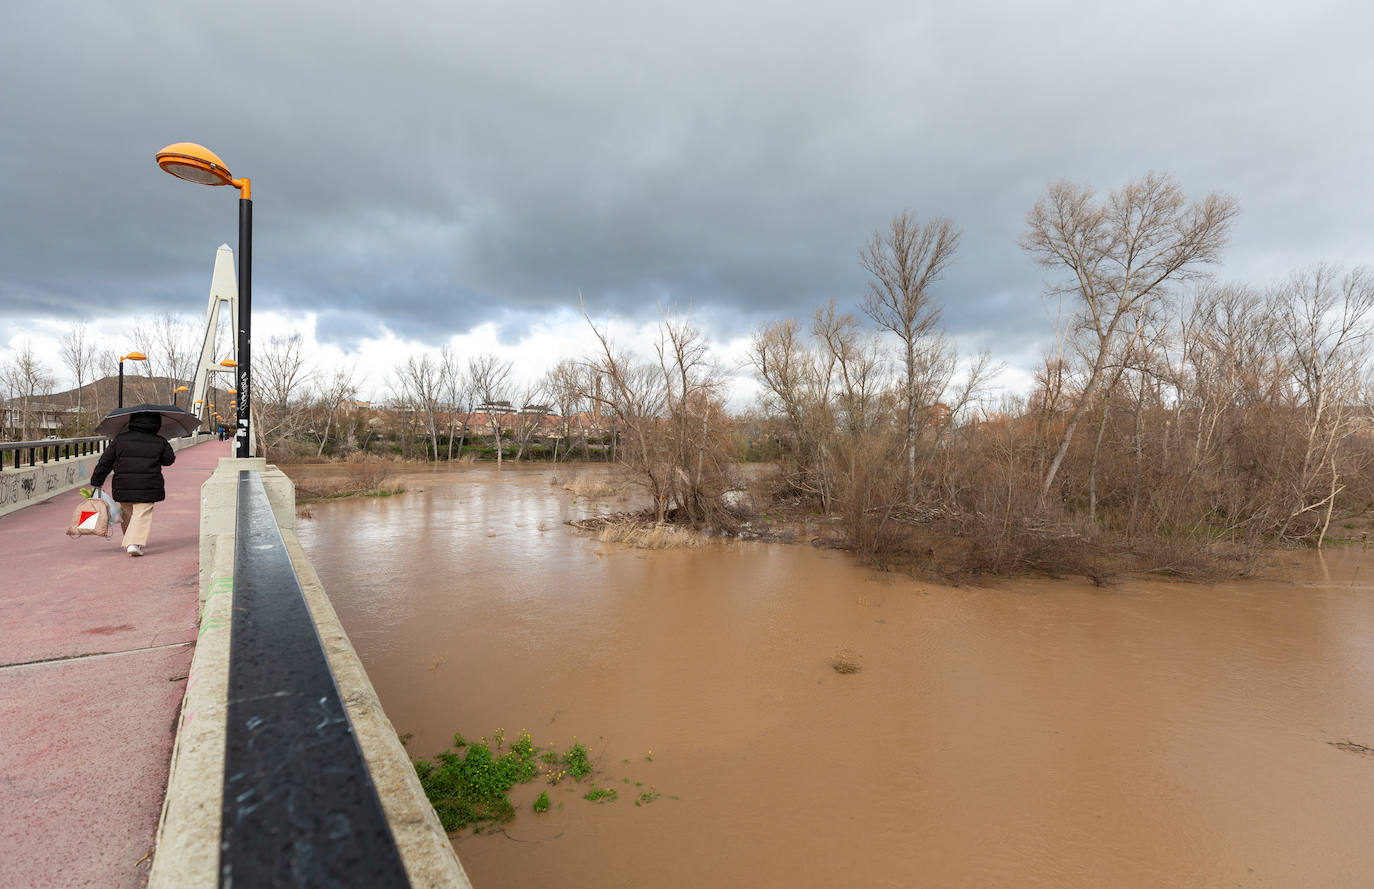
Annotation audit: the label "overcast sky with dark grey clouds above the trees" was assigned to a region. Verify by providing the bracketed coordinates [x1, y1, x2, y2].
[0, 0, 1374, 401]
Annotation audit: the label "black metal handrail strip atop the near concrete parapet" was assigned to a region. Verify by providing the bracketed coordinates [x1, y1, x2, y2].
[220, 470, 409, 889]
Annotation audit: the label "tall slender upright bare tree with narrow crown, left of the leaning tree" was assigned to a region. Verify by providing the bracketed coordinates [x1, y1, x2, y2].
[859, 210, 959, 503]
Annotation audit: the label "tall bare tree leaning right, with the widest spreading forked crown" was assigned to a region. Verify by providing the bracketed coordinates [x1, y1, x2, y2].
[1021, 173, 1237, 499]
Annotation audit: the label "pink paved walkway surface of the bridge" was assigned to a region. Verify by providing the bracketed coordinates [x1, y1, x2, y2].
[0, 441, 232, 889]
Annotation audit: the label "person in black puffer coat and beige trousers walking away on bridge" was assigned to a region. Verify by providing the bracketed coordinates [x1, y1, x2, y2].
[91, 411, 176, 555]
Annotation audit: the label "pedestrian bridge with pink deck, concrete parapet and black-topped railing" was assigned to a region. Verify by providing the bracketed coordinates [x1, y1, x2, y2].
[0, 436, 469, 889]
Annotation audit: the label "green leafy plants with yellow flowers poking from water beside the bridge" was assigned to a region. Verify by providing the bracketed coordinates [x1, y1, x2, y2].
[403, 728, 665, 833]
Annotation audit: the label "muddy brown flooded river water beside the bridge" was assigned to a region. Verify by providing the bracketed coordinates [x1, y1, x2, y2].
[298, 466, 1374, 889]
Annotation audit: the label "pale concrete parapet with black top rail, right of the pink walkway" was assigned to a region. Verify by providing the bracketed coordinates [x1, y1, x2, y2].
[148, 458, 470, 889]
